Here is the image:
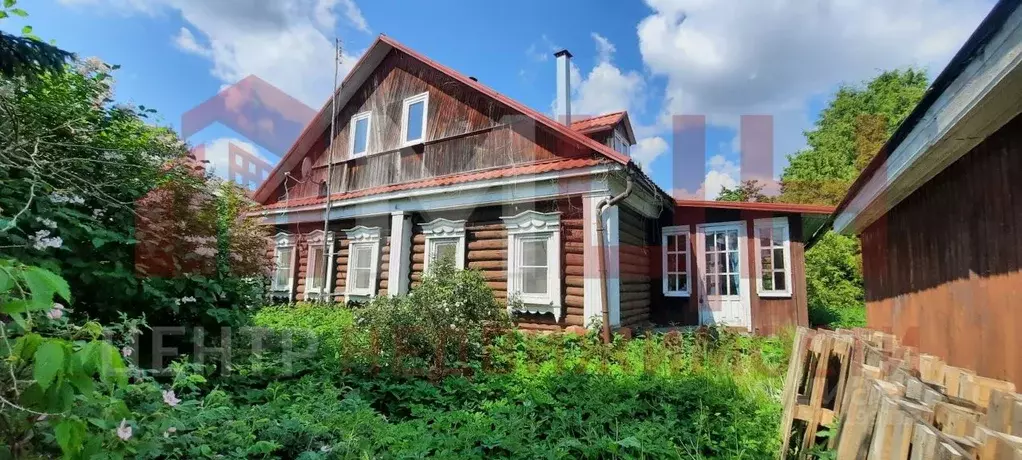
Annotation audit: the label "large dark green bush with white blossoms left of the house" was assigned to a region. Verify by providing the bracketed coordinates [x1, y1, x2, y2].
[0, 55, 265, 326]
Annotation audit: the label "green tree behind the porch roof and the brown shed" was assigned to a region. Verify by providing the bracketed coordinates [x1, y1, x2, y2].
[778, 68, 928, 326]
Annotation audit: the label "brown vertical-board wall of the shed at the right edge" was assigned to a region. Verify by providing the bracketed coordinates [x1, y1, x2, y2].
[861, 112, 1022, 385]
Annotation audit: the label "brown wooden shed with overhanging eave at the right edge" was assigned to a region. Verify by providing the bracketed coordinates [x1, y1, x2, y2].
[833, 0, 1022, 385]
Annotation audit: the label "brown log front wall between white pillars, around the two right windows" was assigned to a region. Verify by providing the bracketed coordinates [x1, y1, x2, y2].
[411, 197, 585, 330]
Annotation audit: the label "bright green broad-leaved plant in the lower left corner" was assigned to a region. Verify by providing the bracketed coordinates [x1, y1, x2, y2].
[0, 260, 128, 457]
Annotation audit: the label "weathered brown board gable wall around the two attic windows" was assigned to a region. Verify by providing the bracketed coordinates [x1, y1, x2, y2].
[267, 51, 592, 203]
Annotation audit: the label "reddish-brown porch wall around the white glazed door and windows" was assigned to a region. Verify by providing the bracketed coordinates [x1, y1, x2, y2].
[650, 208, 808, 335]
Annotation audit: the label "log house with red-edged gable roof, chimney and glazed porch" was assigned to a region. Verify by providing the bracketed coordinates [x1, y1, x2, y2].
[254, 36, 831, 332]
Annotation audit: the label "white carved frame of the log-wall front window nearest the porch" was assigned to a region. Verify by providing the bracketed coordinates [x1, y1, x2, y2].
[501, 211, 561, 321]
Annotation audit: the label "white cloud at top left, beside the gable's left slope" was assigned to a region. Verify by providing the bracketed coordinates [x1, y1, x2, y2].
[60, 0, 368, 107]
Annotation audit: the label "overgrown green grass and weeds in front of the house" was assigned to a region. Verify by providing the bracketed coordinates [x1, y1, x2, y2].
[193, 306, 790, 458]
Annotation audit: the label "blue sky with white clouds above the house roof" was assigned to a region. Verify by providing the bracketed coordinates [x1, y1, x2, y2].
[6, 0, 991, 197]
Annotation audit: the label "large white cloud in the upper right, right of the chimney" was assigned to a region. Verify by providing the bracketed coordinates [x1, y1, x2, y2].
[638, 0, 991, 190]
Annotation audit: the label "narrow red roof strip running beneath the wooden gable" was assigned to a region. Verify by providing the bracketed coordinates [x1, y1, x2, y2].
[258, 157, 608, 210]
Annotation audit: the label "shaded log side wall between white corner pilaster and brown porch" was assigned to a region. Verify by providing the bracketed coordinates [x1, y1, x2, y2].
[618, 206, 660, 326]
